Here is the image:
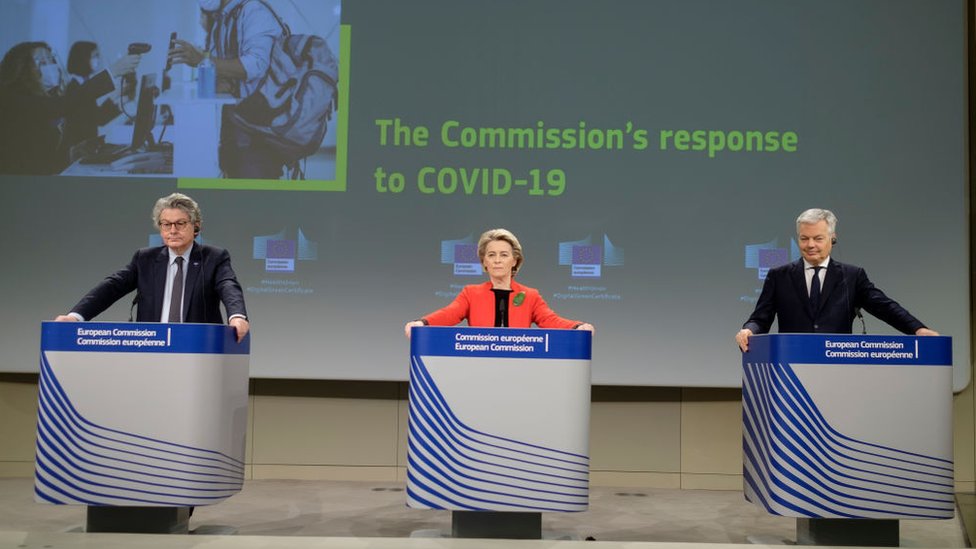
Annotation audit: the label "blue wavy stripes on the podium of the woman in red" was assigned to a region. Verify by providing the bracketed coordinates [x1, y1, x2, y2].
[407, 356, 590, 512]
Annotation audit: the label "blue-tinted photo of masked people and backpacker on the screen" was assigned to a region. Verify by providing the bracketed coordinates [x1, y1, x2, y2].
[0, 0, 345, 186]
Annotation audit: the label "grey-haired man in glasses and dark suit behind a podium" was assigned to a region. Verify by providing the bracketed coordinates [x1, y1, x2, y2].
[55, 193, 250, 341]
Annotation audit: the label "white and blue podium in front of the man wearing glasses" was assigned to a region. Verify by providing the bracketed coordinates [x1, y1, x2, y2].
[34, 322, 250, 533]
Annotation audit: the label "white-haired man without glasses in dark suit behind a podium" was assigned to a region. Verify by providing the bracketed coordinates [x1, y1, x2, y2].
[735, 208, 939, 352]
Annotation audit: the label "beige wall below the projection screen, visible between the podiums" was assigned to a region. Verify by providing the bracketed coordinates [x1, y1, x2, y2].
[0, 374, 976, 491]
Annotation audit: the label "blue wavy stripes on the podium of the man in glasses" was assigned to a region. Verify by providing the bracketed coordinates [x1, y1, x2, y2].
[34, 354, 244, 506]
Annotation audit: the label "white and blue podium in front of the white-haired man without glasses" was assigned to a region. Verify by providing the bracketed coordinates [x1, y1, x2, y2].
[742, 334, 955, 545]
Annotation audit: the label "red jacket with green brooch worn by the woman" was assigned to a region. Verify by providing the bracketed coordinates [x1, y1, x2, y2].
[423, 280, 581, 328]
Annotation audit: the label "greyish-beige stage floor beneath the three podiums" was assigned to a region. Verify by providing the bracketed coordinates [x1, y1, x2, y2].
[0, 479, 967, 549]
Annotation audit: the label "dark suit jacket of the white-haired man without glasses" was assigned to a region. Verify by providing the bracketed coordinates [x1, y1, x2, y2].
[742, 258, 925, 334]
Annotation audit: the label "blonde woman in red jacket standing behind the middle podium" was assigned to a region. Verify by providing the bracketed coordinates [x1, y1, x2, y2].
[404, 229, 593, 338]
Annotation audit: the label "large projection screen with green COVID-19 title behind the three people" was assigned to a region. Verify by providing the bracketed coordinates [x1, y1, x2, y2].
[0, 0, 971, 390]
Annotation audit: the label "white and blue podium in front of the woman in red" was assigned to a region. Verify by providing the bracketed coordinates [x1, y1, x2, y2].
[407, 327, 592, 538]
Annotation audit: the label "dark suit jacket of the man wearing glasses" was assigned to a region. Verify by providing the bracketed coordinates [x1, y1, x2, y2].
[71, 243, 247, 324]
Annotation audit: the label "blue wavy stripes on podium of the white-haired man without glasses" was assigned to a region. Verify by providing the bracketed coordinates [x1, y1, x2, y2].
[742, 363, 955, 519]
